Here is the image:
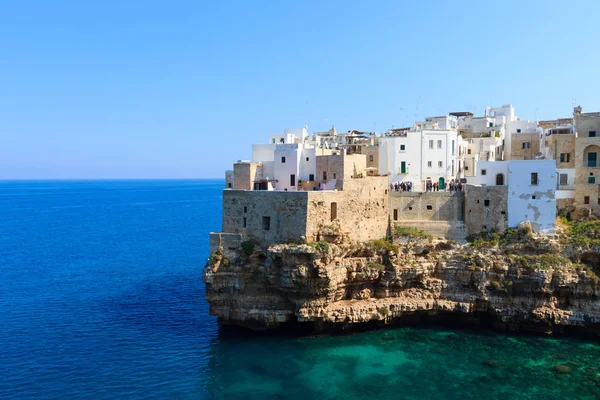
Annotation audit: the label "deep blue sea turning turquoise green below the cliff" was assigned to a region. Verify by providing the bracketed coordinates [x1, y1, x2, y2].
[0, 181, 600, 400]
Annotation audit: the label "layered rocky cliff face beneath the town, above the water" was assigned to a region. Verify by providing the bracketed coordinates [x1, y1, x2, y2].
[203, 233, 600, 336]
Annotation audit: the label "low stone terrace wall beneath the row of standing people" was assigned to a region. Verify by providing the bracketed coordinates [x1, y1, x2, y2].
[389, 192, 464, 223]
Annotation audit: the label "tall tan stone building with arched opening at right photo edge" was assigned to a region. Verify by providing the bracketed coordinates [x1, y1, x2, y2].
[573, 107, 600, 215]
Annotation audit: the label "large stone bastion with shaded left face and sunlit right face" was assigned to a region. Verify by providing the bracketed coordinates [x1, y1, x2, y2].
[211, 177, 389, 248]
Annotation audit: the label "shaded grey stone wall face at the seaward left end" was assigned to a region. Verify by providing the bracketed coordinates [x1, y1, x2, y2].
[222, 190, 311, 244]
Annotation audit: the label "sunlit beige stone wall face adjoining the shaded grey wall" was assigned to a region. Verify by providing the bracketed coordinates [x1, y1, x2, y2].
[306, 177, 389, 242]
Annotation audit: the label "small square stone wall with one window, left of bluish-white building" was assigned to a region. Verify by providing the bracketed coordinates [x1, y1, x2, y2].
[465, 185, 508, 235]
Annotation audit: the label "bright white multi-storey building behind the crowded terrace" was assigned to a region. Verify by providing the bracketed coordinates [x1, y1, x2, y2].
[379, 117, 462, 191]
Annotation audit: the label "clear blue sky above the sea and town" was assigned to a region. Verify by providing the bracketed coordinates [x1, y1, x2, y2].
[0, 0, 600, 179]
